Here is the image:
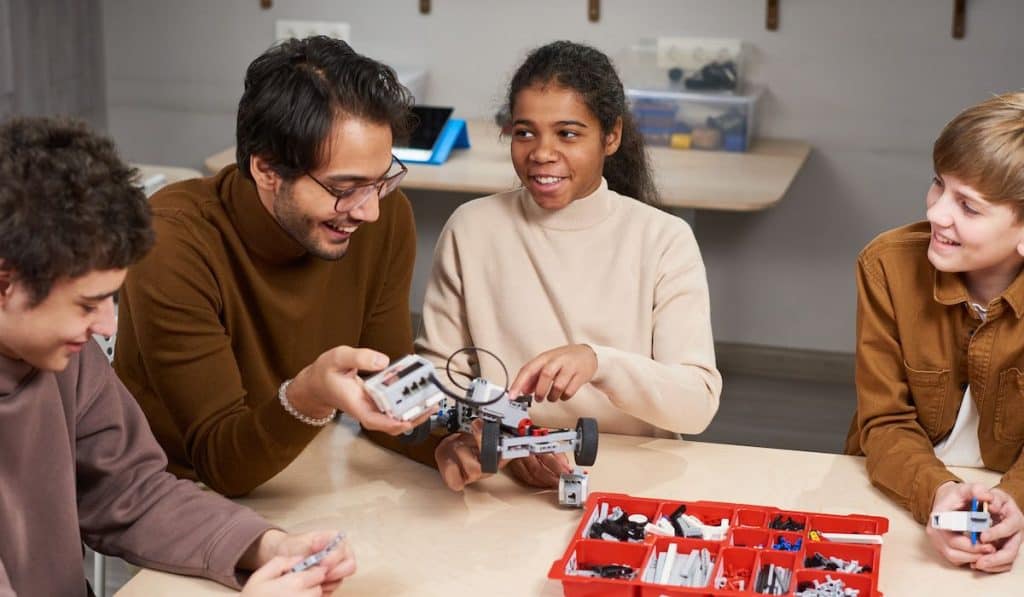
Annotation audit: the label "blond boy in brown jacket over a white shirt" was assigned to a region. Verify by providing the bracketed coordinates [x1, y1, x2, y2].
[846, 93, 1024, 572]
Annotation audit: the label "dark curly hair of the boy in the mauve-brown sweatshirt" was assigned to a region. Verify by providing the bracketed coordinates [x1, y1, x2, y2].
[0, 118, 154, 304]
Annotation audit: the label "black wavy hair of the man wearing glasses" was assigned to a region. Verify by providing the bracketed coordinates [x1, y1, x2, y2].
[234, 36, 414, 180]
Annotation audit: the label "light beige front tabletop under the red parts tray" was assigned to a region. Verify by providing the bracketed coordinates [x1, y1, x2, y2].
[118, 425, 1024, 597]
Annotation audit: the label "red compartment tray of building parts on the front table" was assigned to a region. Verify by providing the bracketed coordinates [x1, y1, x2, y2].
[548, 493, 889, 597]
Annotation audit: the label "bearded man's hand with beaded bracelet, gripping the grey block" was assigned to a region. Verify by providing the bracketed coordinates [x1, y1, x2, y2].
[288, 346, 437, 435]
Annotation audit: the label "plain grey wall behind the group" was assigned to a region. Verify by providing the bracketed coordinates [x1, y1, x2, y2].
[103, 0, 1024, 351]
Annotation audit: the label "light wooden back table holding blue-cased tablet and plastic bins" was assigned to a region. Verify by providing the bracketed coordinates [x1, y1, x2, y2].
[206, 120, 810, 211]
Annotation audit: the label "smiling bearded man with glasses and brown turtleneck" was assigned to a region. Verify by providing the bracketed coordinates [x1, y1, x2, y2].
[114, 37, 433, 496]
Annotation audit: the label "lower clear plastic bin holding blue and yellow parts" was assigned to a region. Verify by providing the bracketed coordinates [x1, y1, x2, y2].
[626, 88, 761, 152]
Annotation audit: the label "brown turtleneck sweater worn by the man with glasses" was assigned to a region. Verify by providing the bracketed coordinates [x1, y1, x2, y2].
[114, 166, 433, 496]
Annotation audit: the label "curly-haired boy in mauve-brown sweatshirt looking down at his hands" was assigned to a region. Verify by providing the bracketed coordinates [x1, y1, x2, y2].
[0, 119, 355, 597]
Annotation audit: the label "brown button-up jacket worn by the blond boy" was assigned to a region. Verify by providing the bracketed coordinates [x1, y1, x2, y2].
[846, 222, 1024, 522]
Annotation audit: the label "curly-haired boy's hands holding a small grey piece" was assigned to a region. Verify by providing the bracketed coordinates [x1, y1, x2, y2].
[239, 529, 355, 597]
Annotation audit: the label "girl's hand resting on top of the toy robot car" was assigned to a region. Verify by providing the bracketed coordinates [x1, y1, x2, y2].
[509, 344, 597, 402]
